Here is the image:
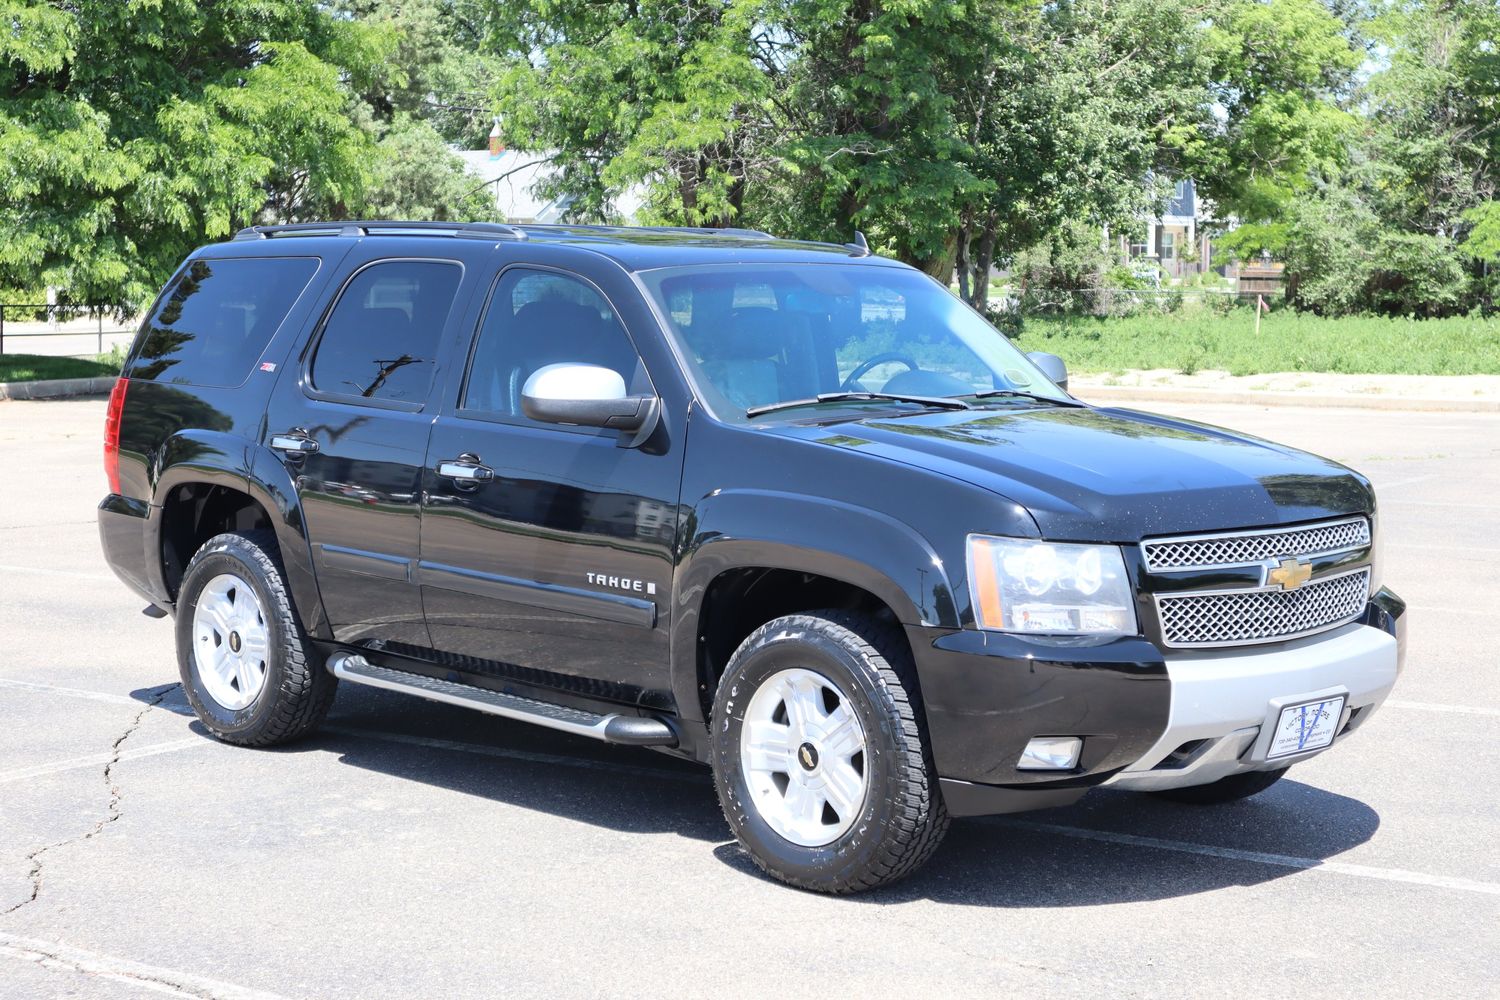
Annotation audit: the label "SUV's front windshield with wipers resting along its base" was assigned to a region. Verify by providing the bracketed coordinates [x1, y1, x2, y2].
[641, 264, 1068, 420]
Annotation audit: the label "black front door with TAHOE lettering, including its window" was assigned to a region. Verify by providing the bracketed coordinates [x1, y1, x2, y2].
[419, 265, 683, 708]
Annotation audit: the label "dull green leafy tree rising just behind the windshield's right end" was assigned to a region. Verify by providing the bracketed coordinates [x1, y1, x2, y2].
[954, 0, 1211, 310]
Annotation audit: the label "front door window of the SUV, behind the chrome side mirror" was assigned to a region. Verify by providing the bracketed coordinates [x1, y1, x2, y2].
[464, 268, 648, 418]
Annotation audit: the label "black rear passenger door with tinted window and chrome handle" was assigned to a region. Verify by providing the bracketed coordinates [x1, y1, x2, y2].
[266, 248, 473, 651]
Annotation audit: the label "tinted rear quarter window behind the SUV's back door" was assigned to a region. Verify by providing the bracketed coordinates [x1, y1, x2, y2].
[129, 256, 318, 385]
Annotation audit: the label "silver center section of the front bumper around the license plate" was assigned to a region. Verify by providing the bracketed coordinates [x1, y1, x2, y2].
[1110, 625, 1397, 792]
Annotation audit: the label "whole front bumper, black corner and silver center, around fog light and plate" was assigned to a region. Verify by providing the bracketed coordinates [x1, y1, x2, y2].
[909, 589, 1406, 816]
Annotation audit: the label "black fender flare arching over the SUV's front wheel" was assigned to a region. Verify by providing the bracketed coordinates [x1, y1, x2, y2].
[671, 489, 959, 723]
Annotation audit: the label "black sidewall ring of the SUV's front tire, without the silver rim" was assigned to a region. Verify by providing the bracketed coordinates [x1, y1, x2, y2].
[713, 624, 903, 891]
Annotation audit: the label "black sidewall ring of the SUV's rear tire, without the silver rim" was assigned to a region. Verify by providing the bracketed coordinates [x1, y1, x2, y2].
[177, 538, 287, 735]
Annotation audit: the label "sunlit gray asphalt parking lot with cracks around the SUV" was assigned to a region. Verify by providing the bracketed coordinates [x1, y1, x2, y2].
[0, 400, 1500, 1000]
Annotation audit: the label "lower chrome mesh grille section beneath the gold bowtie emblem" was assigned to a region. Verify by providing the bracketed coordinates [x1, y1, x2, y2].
[1157, 567, 1370, 648]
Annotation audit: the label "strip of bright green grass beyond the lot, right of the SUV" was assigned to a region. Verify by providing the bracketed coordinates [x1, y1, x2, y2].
[1016, 306, 1500, 375]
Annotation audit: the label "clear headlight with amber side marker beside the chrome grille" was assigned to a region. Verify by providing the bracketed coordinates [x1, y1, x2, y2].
[969, 535, 1137, 636]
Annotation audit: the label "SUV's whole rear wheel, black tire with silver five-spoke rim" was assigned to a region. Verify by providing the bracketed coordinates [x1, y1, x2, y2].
[177, 531, 339, 747]
